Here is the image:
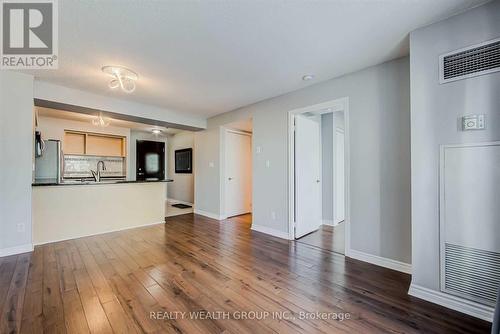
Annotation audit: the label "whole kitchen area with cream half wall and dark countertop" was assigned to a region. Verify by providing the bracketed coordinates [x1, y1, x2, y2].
[32, 106, 186, 245]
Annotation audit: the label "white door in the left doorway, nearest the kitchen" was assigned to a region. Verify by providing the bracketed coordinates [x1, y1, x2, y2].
[225, 130, 252, 217]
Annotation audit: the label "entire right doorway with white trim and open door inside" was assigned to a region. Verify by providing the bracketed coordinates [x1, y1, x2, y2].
[289, 98, 350, 255]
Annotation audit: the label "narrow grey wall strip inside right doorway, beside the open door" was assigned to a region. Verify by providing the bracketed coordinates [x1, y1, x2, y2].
[321, 113, 335, 223]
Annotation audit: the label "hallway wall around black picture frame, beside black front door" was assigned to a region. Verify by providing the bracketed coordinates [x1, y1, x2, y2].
[167, 131, 194, 203]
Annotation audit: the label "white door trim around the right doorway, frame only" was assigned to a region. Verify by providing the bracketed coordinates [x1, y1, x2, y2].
[288, 96, 351, 256]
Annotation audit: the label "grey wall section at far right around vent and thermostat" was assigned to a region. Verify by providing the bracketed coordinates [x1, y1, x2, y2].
[410, 1, 500, 290]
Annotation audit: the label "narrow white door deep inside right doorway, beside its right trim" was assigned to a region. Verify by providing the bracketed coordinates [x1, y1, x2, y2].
[334, 129, 345, 224]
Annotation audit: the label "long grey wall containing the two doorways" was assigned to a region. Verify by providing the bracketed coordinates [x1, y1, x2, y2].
[202, 58, 411, 263]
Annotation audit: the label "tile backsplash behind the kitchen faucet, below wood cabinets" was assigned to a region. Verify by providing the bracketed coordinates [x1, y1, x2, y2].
[63, 154, 126, 178]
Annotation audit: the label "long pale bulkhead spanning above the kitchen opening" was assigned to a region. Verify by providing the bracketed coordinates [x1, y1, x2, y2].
[34, 81, 206, 128]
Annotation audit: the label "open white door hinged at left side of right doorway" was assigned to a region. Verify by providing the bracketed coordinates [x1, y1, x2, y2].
[295, 115, 322, 238]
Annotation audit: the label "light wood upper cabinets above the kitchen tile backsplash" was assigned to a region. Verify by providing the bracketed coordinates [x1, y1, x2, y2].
[63, 131, 126, 157]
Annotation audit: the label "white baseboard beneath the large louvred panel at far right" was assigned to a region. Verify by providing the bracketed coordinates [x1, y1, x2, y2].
[408, 283, 494, 322]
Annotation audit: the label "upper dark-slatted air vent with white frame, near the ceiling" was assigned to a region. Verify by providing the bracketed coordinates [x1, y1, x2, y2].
[439, 38, 500, 83]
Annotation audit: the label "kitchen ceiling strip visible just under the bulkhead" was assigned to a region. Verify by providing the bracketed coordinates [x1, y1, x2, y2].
[36, 107, 185, 136]
